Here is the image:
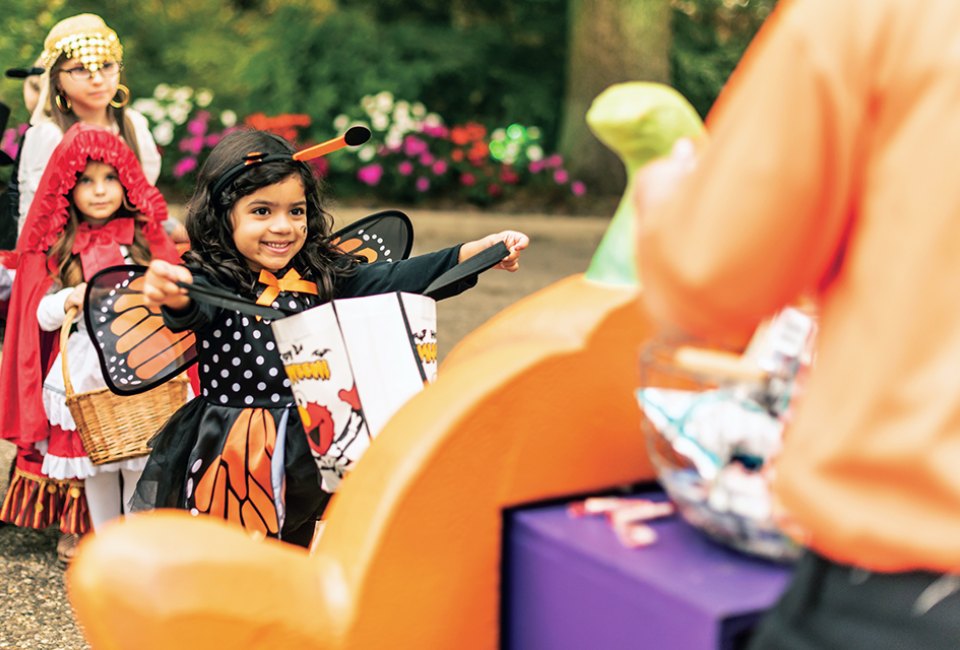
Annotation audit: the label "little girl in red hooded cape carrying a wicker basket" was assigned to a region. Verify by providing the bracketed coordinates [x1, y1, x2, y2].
[0, 124, 179, 533]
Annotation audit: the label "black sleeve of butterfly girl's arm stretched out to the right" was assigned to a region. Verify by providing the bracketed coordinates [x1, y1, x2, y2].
[336, 245, 477, 300]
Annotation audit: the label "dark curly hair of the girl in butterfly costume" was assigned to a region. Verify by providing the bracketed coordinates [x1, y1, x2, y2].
[184, 130, 357, 301]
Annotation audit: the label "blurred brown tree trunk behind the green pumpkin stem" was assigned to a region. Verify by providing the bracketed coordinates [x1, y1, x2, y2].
[559, 0, 671, 195]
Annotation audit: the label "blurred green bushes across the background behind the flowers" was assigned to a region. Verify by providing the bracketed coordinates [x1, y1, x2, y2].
[0, 0, 775, 208]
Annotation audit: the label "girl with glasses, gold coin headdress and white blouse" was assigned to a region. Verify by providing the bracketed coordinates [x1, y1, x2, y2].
[18, 14, 160, 232]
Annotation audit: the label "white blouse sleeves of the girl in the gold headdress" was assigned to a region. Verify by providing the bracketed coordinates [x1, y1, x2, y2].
[17, 108, 160, 235]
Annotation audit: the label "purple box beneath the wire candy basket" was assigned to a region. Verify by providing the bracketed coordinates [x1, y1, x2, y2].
[501, 492, 790, 650]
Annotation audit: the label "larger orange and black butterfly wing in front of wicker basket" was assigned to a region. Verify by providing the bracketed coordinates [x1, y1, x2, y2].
[83, 265, 197, 395]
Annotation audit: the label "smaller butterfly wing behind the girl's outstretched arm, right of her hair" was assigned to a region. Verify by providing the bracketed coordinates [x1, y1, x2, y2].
[330, 210, 413, 262]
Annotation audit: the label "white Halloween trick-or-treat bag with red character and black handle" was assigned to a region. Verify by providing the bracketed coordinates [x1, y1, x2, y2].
[271, 245, 509, 491]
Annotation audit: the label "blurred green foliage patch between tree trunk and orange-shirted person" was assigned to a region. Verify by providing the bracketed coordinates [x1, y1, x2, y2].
[670, 0, 776, 116]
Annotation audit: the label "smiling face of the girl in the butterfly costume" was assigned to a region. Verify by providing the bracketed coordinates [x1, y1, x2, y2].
[230, 174, 307, 273]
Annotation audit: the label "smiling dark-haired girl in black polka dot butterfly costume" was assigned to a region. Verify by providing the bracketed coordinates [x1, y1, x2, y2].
[134, 131, 529, 546]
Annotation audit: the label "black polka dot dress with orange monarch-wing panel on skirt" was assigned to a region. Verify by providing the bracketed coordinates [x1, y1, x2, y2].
[134, 246, 476, 538]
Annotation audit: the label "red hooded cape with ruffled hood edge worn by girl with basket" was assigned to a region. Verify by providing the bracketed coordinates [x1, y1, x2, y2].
[0, 124, 180, 447]
